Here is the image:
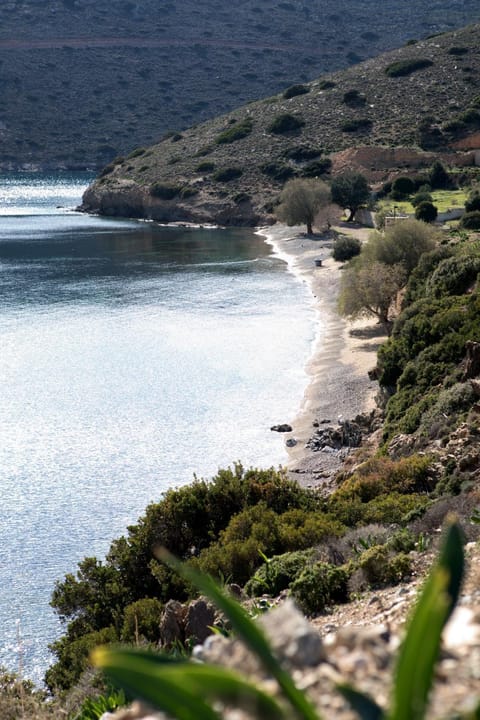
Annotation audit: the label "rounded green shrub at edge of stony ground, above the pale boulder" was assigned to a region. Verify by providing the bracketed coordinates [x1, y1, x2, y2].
[290, 562, 349, 615]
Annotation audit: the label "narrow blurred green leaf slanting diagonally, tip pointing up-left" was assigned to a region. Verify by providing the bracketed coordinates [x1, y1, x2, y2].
[158, 549, 321, 720]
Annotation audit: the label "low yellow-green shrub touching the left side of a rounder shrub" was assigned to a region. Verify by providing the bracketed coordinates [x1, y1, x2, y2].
[245, 548, 315, 597]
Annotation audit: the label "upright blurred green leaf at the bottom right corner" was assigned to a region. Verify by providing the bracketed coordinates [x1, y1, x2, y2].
[389, 524, 464, 720]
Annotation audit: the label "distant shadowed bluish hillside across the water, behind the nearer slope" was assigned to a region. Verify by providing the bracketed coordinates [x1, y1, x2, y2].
[0, 0, 480, 169]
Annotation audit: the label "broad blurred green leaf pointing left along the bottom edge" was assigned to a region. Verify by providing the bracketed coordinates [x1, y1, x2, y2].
[92, 646, 285, 720]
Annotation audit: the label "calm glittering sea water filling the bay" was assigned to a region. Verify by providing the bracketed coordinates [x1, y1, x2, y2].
[0, 175, 314, 683]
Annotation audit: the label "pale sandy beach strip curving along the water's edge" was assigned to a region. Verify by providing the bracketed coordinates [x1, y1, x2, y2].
[258, 224, 385, 485]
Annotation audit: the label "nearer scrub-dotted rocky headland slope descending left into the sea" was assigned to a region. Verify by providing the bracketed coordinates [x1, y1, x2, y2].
[83, 25, 480, 225]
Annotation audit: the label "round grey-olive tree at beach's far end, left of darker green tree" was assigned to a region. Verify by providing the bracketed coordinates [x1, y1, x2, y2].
[275, 178, 332, 235]
